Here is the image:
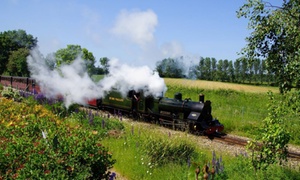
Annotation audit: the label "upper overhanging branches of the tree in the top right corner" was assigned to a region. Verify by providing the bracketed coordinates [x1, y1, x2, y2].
[237, 0, 300, 93]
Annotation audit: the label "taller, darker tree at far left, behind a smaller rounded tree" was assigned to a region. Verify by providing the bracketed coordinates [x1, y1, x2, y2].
[0, 30, 37, 74]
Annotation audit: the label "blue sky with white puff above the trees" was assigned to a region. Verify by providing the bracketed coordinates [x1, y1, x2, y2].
[0, 0, 281, 68]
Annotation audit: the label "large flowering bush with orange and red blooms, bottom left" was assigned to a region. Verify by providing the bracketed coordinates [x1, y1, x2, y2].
[0, 99, 115, 179]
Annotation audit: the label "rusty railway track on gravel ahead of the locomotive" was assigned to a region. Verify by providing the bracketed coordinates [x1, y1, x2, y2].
[208, 135, 300, 161]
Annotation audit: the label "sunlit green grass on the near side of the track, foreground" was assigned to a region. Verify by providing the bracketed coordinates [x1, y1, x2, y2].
[102, 121, 299, 180]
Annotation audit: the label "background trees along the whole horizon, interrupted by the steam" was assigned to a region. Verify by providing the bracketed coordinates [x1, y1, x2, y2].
[0, 30, 276, 85]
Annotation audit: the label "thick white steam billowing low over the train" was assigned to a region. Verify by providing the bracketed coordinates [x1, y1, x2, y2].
[27, 50, 167, 107]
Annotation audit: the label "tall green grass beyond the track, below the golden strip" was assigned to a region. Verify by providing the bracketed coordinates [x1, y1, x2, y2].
[165, 84, 300, 145]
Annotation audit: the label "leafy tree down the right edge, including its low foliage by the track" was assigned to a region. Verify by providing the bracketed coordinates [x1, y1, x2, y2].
[238, 0, 300, 169]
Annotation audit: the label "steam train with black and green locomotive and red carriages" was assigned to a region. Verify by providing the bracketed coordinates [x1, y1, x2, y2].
[0, 76, 224, 135]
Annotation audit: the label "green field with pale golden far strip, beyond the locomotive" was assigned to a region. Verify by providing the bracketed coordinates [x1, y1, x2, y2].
[165, 78, 300, 145]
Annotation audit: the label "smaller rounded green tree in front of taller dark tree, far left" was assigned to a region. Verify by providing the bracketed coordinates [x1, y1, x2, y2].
[6, 48, 29, 77]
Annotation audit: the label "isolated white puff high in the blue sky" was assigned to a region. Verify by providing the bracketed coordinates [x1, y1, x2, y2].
[112, 10, 158, 45]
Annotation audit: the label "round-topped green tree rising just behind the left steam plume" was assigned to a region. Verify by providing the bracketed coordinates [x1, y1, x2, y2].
[55, 45, 95, 74]
